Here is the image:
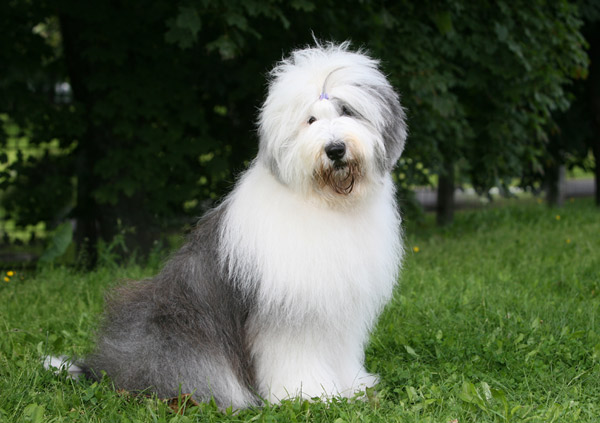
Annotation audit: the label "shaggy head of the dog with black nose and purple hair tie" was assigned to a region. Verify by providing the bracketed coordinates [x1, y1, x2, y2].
[258, 43, 407, 202]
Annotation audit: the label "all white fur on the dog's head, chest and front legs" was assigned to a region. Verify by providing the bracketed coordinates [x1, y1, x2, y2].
[220, 44, 406, 402]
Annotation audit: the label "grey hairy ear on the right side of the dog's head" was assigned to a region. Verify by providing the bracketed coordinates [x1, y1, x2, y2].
[380, 86, 408, 170]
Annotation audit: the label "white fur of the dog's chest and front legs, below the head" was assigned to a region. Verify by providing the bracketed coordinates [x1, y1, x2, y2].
[222, 164, 402, 401]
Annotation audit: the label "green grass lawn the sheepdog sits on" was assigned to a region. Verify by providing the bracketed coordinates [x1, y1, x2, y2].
[0, 200, 600, 423]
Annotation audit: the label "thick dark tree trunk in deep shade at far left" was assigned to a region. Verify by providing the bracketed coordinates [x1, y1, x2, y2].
[59, 11, 166, 268]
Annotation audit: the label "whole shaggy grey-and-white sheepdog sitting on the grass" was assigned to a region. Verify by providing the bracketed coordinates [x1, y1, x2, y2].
[50, 43, 407, 409]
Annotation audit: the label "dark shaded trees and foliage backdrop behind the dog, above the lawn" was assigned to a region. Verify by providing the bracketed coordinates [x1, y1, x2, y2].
[0, 0, 600, 268]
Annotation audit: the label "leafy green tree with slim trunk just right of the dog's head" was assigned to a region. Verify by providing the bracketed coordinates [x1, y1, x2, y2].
[360, 1, 587, 224]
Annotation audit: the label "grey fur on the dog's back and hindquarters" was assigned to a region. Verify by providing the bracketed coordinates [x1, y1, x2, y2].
[84, 202, 260, 408]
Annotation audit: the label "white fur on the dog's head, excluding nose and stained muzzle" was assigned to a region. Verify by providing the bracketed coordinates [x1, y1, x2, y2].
[258, 43, 407, 201]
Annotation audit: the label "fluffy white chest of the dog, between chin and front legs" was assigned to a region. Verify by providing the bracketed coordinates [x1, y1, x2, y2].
[220, 171, 402, 320]
